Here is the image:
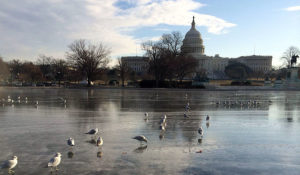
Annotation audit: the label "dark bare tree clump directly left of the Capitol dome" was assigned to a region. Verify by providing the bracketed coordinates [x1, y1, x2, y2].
[142, 32, 198, 87]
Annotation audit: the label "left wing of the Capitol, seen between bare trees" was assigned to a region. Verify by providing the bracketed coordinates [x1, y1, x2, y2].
[121, 56, 149, 75]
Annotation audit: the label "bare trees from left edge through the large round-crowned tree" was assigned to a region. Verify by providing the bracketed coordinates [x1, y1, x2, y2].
[0, 40, 110, 86]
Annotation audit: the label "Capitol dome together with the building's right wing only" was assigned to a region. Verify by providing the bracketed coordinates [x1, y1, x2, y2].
[181, 18, 272, 78]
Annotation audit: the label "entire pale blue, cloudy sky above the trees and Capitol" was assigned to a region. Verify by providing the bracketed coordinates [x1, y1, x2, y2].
[0, 0, 300, 65]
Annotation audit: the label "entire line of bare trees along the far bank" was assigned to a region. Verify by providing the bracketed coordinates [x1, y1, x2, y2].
[0, 32, 300, 87]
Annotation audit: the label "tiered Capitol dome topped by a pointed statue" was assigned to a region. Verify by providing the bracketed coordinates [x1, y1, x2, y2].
[181, 17, 204, 56]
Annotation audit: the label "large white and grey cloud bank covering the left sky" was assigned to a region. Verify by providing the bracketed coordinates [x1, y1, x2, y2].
[0, 0, 235, 58]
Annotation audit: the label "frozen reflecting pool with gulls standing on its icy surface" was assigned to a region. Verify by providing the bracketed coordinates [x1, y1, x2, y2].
[0, 88, 300, 175]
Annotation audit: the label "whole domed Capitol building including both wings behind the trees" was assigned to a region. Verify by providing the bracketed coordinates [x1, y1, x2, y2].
[122, 17, 272, 79]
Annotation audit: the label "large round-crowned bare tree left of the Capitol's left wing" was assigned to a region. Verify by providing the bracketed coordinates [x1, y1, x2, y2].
[67, 39, 110, 86]
